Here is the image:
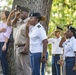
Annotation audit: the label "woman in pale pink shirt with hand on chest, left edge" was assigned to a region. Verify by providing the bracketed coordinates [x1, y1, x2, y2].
[0, 11, 12, 75]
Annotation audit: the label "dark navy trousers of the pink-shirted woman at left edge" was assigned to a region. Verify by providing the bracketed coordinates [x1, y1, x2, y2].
[0, 42, 8, 75]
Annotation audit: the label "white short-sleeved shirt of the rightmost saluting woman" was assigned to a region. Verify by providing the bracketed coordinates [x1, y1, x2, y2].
[62, 37, 76, 57]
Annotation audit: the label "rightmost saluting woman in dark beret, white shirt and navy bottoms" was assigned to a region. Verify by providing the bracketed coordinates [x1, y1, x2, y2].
[60, 26, 76, 75]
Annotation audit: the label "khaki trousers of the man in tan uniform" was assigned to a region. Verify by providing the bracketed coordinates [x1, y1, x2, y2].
[16, 47, 32, 75]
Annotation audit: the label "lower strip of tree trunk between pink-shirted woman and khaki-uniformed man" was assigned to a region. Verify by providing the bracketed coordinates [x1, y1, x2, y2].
[7, 32, 16, 75]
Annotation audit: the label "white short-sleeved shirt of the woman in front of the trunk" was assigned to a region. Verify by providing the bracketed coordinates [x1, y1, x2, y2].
[29, 23, 47, 53]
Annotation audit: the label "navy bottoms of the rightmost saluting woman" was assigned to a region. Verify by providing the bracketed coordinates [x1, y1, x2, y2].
[66, 57, 76, 75]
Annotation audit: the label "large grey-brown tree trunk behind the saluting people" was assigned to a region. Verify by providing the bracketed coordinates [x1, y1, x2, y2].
[8, 0, 53, 75]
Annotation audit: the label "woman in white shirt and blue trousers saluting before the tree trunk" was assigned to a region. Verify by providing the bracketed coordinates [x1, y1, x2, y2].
[29, 12, 47, 75]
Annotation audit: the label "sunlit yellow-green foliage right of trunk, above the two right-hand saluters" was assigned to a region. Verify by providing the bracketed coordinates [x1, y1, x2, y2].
[48, 0, 76, 34]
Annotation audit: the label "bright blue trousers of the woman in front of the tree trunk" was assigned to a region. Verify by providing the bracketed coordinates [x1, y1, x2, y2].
[31, 53, 48, 75]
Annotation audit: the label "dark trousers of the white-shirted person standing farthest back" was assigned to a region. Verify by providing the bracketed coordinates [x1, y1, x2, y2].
[52, 54, 61, 75]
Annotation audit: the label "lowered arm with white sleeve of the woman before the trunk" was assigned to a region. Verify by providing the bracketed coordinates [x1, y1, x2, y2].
[38, 26, 48, 62]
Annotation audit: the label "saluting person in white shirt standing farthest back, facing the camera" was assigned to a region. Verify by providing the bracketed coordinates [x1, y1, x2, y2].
[48, 30, 63, 75]
